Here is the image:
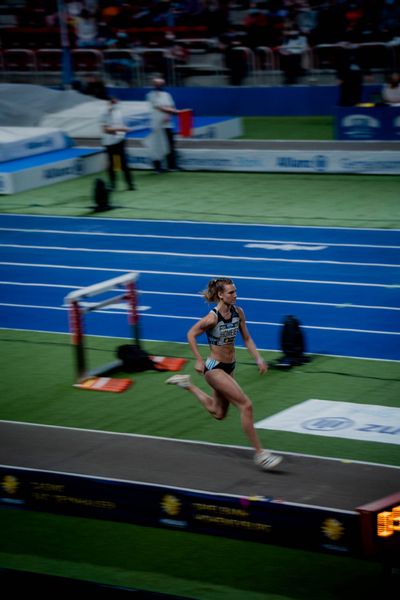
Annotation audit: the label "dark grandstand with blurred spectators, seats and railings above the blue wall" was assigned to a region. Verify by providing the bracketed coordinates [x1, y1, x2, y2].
[0, 0, 400, 86]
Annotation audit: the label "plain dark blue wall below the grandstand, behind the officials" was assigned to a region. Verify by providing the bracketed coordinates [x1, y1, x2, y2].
[109, 85, 382, 117]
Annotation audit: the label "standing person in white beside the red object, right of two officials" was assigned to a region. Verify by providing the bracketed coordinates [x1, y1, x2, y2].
[146, 77, 179, 173]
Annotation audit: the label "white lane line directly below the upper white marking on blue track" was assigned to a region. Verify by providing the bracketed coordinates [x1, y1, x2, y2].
[0, 244, 400, 269]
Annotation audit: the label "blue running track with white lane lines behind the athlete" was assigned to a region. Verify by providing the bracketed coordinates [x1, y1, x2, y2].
[0, 215, 400, 361]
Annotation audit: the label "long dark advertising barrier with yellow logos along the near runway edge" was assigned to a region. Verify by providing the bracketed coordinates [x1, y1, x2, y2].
[0, 465, 362, 557]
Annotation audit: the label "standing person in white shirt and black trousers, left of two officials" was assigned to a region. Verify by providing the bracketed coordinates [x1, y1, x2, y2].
[101, 97, 135, 190]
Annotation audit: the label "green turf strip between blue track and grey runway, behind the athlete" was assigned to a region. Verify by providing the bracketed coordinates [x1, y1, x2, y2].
[0, 328, 400, 465]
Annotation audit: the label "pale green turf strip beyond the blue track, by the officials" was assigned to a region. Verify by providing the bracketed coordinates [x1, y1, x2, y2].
[0, 171, 400, 228]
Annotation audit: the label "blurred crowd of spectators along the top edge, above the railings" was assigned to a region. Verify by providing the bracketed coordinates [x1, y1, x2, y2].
[3, 0, 400, 48]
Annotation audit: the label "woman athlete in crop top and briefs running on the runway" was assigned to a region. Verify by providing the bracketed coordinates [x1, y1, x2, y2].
[166, 278, 282, 470]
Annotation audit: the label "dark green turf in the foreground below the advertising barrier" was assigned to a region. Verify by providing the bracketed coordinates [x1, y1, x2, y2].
[0, 510, 396, 600]
